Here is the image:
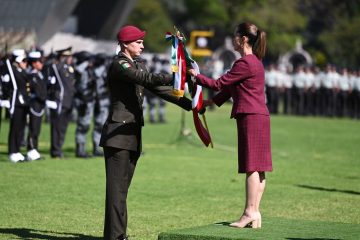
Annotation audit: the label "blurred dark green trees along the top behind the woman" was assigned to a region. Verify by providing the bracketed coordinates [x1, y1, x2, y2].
[128, 0, 360, 68]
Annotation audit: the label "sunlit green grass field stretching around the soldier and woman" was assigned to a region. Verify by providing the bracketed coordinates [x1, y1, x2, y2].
[0, 105, 360, 240]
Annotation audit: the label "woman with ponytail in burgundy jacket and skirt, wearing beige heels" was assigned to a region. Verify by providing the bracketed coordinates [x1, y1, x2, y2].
[189, 23, 272, 228]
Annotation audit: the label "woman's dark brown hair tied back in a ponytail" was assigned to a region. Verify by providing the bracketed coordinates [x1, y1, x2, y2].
[235, 22, 266, 59]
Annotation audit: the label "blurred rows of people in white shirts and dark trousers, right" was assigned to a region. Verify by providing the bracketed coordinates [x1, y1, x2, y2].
[265, 65, 360, 119]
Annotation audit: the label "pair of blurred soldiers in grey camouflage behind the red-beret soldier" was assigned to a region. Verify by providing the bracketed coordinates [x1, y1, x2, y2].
[74, 51, 110, 158]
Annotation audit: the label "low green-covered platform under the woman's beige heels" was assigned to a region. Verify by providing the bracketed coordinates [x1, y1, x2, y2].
[158, 218, 360, 240]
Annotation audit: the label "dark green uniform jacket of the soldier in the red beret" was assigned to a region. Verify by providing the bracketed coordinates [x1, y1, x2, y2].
[100, 53, 191, 153]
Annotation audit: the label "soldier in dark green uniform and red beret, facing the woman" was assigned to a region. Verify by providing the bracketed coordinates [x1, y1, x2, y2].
[100, 26, 191, 240]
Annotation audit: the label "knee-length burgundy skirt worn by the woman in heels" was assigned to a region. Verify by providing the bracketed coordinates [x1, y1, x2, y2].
[236, 114, 272, 173]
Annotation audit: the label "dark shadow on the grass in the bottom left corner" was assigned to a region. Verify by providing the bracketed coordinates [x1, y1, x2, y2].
[0, 228, 103, 240]
